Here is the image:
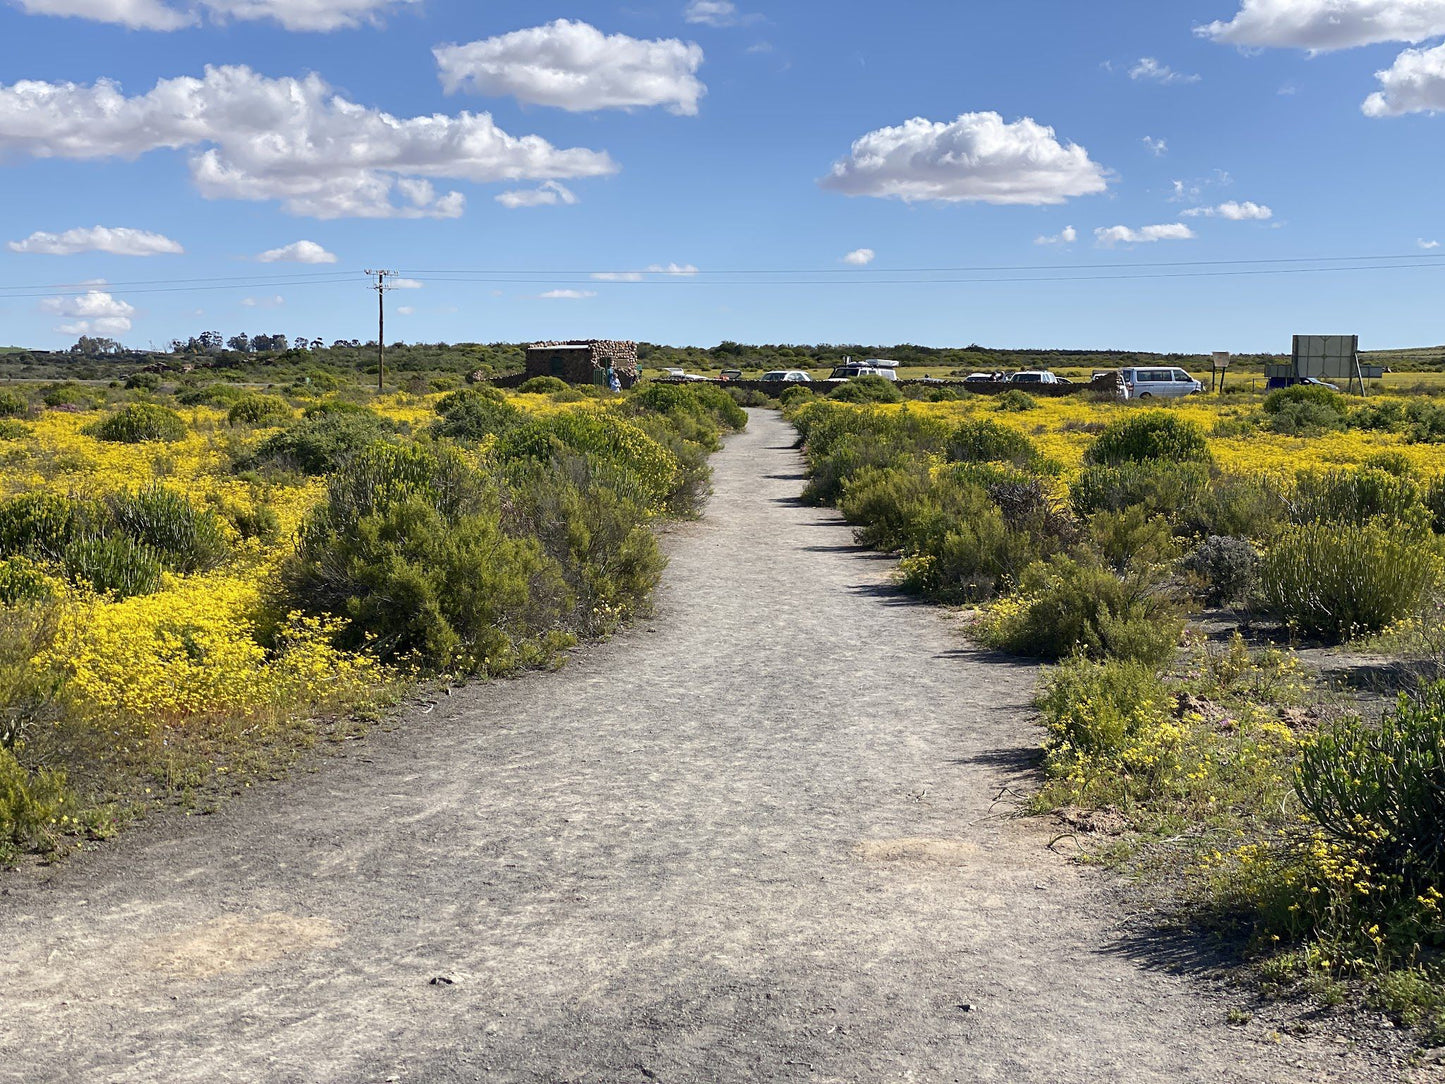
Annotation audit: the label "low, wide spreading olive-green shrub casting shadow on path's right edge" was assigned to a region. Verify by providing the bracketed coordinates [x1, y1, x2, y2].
[983, 556, 1183, 665]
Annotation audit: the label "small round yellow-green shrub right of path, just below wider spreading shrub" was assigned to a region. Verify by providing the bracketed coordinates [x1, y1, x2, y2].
[1038, 659, 1179, 799]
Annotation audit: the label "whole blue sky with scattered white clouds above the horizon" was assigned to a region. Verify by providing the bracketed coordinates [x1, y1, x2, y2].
[0, 0, 1445, 351]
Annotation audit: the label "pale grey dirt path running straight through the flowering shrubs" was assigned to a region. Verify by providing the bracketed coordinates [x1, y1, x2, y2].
[0, 410, 1404, 1084]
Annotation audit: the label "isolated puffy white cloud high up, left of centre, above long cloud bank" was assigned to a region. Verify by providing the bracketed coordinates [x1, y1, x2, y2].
[432, 19, 707, 117]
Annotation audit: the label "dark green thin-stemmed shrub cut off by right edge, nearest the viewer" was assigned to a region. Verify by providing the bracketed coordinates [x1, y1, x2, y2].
[1295, 685, 1445, 899]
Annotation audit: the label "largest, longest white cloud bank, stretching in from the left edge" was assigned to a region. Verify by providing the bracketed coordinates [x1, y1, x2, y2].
[0, 66, 617, 218]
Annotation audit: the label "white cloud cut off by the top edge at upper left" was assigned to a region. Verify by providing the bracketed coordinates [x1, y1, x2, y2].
[16, 0, 420, 30]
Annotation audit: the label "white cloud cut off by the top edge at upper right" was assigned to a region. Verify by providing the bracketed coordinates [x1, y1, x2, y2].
[1194, 0, 1445, 52]
